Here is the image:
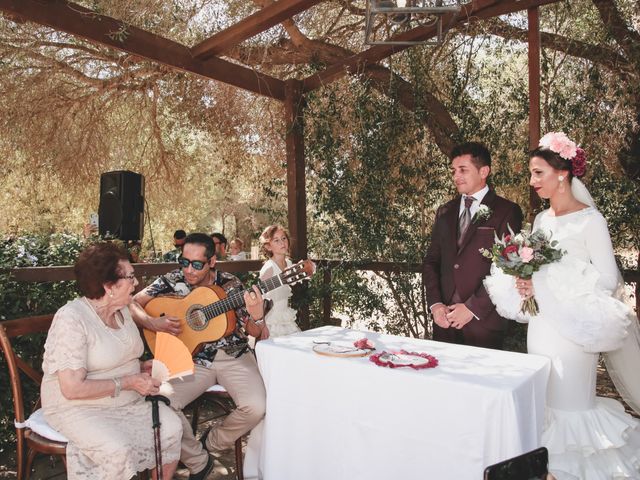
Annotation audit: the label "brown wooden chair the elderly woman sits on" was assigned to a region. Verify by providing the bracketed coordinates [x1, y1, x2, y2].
[0, 315, 67, 480]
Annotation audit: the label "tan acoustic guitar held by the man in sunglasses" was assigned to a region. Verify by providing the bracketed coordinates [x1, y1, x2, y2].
[144, 260, 315, 353]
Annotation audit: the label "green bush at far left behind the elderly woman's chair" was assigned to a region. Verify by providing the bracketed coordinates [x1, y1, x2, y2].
[0, 234, 85, 450]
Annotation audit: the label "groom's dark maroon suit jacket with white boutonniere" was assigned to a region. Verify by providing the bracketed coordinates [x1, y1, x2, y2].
[422, 189, 522, 330]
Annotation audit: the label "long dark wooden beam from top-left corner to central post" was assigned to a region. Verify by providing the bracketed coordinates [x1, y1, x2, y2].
[0, 0, 284, 101]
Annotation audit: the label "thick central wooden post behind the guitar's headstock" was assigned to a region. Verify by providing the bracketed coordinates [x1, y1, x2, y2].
[284, 79, 309, 330]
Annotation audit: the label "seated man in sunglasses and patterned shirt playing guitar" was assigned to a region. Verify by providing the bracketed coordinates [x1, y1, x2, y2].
[131, 233, 269, 480]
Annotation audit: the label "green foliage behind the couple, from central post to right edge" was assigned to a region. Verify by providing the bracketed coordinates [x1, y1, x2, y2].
[294, 14, 640, 344]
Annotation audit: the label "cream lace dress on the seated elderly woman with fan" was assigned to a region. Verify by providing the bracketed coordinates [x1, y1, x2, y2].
[41, 298, 182, 480]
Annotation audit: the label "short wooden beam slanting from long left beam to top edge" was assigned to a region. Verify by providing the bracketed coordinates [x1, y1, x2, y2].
[191, 0, 322, 60]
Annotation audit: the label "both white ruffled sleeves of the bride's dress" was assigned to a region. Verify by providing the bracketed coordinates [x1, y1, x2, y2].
[484, 213, 633, 352]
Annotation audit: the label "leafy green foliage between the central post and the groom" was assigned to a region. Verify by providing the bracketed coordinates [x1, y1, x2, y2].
[306, 73, 440, 336]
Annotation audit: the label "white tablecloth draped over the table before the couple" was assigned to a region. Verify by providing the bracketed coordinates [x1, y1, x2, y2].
[256, 327, 549, 480]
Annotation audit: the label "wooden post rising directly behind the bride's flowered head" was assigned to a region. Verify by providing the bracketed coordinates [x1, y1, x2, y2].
[527, 7, 540, 216]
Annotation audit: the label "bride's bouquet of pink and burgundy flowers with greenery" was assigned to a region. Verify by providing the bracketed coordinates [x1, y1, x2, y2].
[480, 224, 565, 316]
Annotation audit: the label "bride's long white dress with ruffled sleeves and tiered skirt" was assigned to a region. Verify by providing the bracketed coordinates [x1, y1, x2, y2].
[485, 207, 640, 480]
